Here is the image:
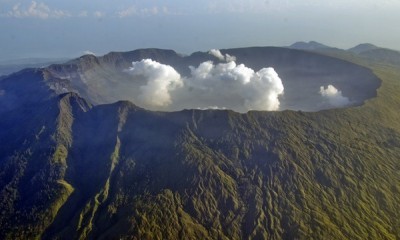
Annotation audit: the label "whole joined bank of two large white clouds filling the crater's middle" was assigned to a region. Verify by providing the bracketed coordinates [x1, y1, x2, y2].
[129, 59, 284, 112]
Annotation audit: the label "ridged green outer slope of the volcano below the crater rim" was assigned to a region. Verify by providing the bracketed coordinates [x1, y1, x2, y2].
[0, 49, 400, 239]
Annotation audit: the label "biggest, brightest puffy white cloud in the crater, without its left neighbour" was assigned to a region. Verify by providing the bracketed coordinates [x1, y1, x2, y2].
[185, 61, 284, 112]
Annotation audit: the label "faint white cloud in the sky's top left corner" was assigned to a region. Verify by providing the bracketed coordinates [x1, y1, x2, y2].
[7, 1, 71, 19]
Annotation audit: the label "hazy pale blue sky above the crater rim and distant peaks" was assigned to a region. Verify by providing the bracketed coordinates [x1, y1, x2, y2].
[0, 0, 400, 59]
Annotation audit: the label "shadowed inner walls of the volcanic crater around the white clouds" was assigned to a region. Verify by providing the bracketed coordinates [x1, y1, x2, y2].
[41, 47, 380, 111]
